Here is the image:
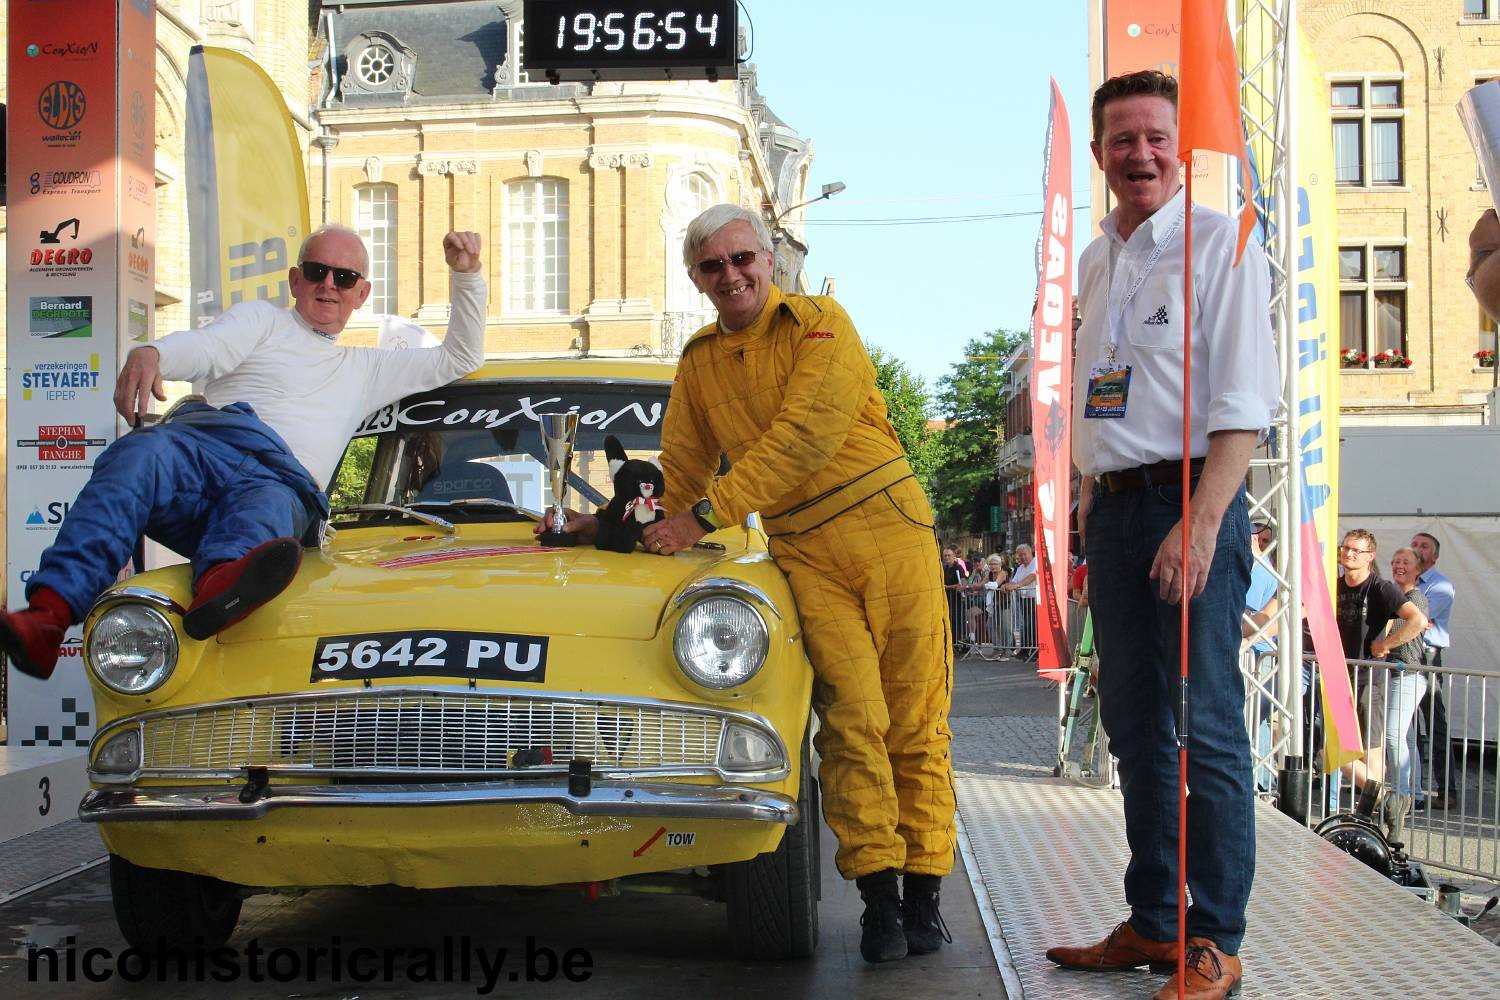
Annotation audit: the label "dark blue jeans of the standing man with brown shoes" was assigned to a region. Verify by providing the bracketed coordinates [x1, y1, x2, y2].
[1086, 486, 1256, 955]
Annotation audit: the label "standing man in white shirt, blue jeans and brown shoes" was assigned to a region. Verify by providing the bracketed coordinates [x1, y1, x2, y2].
[1047, 70, 1278, 1000]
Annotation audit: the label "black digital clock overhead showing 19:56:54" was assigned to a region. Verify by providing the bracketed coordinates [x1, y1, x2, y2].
[522, 0, 738, 81]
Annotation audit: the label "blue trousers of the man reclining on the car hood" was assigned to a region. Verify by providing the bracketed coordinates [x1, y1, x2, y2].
[26, 423, 314, 621]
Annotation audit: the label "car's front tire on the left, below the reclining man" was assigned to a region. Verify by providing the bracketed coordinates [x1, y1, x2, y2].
[110, 855, 243, 952]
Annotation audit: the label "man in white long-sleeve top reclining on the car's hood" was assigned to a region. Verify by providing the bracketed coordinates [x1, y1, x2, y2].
[0, 226, 486, 679]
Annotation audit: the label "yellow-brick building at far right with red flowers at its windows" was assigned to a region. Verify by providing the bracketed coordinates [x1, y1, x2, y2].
[1298, 0, 1500, 426]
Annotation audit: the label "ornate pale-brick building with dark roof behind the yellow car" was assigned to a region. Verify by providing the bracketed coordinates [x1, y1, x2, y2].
[309, 0, 812, 355]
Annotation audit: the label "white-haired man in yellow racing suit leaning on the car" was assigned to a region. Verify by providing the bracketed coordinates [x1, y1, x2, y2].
[546, 205, 957, 963]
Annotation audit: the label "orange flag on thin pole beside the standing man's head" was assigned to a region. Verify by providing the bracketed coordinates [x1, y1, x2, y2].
[1178, 0, 1256, 264]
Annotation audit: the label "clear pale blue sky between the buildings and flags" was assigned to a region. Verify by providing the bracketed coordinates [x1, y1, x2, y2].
[740, 0, 1092, 407]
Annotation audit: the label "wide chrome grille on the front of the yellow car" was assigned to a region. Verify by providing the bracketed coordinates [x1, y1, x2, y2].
[143, 691, 723, 774]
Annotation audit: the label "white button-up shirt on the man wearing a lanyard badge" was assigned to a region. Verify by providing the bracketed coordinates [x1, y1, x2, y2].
[1073, 189, 1281, 475]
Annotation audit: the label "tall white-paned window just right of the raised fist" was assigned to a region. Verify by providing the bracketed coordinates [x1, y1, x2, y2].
[506, 177, 569, 313]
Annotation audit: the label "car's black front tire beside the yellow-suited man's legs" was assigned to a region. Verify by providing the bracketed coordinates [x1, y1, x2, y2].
[723, 733, 822, 960]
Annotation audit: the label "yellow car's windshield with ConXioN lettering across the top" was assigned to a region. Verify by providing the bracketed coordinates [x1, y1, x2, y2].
[337, 381, 671, 525]
